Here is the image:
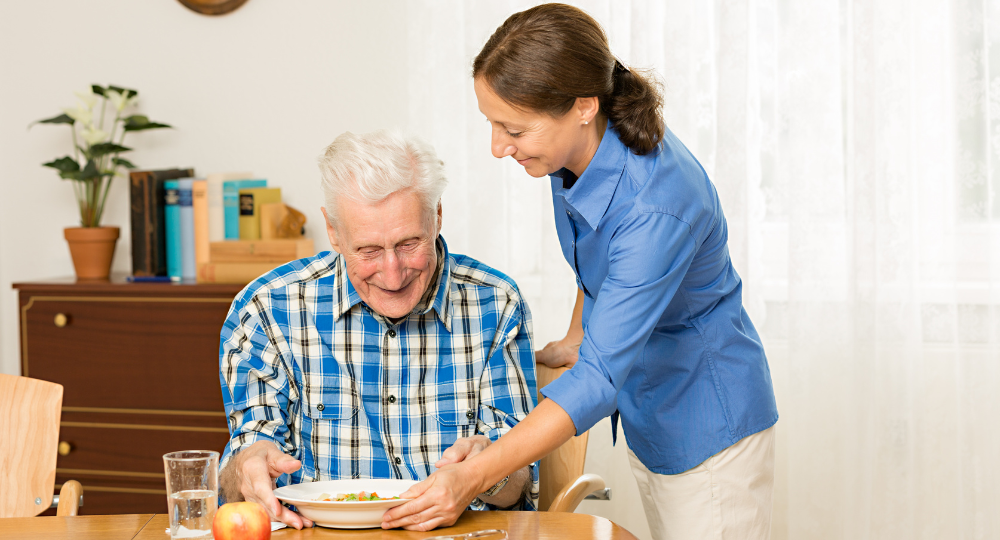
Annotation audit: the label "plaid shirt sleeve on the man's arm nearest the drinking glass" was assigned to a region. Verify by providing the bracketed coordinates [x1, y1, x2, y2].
[219, 307, 295, 469]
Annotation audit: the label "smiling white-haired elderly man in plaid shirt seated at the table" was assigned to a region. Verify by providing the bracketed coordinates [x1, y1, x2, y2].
[219, 131, 538, 528]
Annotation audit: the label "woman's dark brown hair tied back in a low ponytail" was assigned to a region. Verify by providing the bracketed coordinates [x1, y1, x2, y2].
[472, 4, 663, 155]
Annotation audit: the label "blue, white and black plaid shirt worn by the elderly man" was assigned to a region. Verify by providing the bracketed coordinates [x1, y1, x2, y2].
[219, 239, 538, 510]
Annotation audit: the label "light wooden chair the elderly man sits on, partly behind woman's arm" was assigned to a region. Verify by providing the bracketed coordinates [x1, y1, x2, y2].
[535, 364, 611, 512]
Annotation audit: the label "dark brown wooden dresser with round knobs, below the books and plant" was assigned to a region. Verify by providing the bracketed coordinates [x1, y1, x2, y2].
[14, 278, 242, 514]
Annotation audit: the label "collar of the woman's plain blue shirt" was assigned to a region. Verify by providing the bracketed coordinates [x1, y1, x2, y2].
[551, 121, 628, 231]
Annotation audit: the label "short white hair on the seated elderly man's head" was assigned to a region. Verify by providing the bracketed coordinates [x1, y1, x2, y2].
[319, 130, 448, 226]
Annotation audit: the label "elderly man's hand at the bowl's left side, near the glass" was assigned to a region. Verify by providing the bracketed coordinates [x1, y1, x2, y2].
[219, 441, 313, 529]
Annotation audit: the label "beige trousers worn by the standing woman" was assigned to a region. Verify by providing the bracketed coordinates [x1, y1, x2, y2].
[628, 426, 774, 540]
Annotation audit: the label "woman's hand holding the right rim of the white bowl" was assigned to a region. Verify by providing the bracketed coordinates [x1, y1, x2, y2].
[382, 463, 481, 531]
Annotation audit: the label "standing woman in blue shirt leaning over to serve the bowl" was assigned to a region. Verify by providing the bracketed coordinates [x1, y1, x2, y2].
[383, 4, 778, 538]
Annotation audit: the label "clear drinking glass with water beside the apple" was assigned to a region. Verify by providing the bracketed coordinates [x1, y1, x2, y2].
[163, 450, 219, 540]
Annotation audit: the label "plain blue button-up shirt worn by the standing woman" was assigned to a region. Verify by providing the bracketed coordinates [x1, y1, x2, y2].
[542, 123, 778, 474]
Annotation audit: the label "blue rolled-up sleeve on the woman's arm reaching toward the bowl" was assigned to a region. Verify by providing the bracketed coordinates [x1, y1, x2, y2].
[542, 211, 697, 435]
